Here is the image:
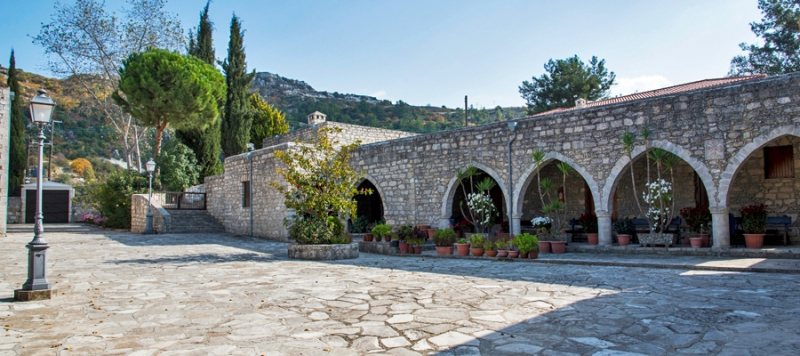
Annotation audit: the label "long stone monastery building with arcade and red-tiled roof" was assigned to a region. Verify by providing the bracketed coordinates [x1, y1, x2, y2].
[205, 74, 800, 249]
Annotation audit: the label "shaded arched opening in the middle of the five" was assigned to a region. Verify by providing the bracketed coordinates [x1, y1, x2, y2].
[517, 159, 595, 241]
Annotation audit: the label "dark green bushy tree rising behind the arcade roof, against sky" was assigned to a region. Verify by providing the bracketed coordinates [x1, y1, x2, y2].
[519, 55, 616, 114]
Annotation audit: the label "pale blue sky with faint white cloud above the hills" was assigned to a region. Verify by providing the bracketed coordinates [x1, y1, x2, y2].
[0, 0, 761, 108]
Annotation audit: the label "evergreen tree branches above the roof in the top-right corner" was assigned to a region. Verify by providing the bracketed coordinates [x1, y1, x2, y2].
[729, 0, 800, 75]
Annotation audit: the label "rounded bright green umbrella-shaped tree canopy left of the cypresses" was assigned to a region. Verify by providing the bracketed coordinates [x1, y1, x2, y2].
[114, 49, 225, 156]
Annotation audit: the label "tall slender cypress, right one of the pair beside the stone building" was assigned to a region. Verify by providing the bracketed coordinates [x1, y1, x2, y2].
[222, 14, 256, 156]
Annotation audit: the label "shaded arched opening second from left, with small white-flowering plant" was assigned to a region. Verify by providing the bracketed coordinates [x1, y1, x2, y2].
[450, 169, 508, 233]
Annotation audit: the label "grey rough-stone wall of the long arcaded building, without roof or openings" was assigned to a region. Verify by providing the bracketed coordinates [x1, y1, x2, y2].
[212, 74, 800, 248]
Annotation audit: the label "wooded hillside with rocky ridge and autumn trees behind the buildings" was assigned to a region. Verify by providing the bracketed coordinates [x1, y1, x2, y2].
[0, 66, 524, 160]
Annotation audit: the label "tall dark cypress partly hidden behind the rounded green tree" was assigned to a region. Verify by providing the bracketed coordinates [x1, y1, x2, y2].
[175, 1, 224, 182]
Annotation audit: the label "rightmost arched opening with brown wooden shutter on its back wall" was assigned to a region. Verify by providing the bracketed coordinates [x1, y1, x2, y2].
[721, 135, 800, 245]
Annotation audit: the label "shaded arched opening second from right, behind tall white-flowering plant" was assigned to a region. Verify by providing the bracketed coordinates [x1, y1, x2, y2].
[607, 147, 713, 247]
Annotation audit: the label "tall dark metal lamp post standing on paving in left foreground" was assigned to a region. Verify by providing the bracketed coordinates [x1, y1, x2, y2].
[14, 89, 56, 301]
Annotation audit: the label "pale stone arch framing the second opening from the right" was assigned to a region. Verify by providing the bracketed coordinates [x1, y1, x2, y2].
[601, 140, 719, 212]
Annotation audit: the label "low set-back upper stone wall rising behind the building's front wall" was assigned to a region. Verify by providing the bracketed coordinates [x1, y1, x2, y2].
[263, 121, 416, 148]
